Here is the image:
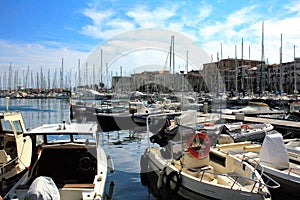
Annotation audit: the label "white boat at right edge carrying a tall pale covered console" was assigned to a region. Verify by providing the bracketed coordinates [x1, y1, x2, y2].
[217, 133, 300, 199]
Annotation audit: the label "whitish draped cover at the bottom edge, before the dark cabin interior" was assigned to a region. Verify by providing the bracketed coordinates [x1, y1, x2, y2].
[25, 176, 60, 200]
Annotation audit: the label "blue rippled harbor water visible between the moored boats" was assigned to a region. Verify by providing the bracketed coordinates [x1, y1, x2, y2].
[0, 98, 296, 200]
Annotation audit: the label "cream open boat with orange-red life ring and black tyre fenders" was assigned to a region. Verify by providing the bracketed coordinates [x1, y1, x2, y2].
[141, 113, 271, 199]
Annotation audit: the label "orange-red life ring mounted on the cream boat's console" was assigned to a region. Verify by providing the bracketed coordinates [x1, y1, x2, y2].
[187, 132, 210, 158]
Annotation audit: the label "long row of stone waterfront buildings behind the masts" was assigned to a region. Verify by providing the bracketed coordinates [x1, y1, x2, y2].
[112, 58, 300, 94]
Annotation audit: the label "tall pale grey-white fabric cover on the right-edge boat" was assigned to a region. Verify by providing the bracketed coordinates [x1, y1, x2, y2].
[259, 133, 289, 169]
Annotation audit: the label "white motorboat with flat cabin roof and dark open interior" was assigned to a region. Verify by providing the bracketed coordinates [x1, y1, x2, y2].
[4, 123, 112, 200]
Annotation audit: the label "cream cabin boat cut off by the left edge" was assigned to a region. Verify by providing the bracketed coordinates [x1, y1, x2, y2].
[0, 112, 32, 195]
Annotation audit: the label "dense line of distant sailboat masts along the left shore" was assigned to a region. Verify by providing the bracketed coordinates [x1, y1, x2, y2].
[0, 58, 112, 91]
